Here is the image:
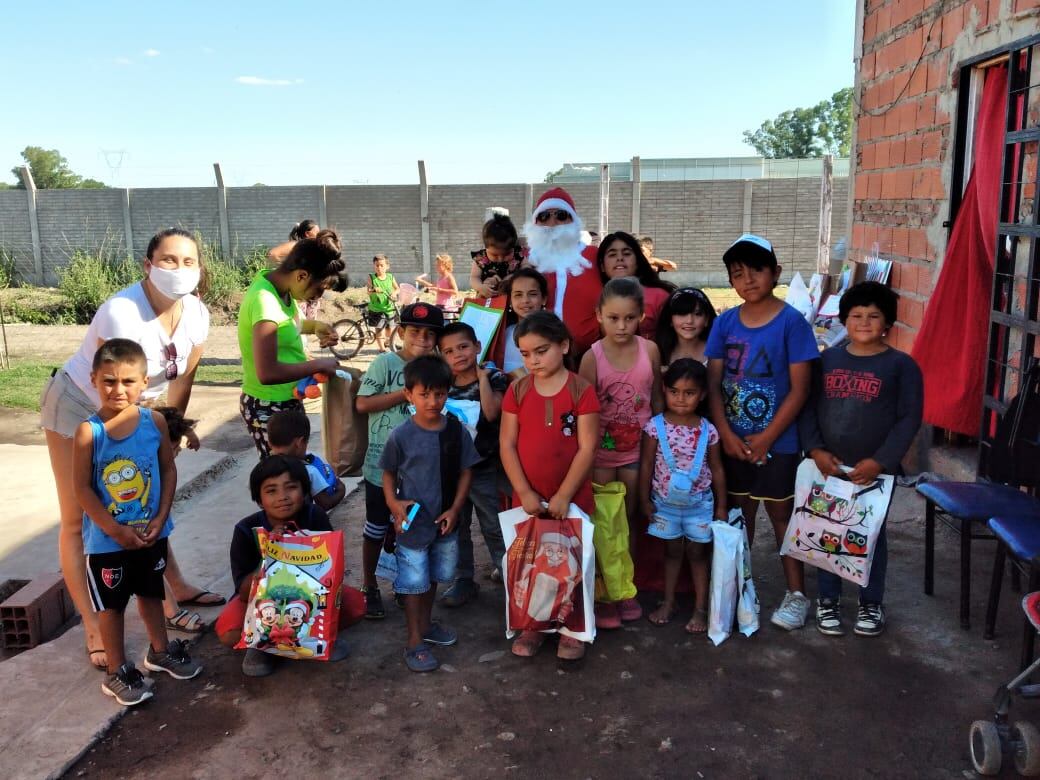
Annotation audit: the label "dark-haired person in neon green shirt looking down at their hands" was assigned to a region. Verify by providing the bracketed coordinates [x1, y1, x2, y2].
[238, 225, 346, 458]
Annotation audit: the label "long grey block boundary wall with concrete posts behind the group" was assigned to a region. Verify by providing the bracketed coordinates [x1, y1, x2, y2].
[0, 178, 848, 284]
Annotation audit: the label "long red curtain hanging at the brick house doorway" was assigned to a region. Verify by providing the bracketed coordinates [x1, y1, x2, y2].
[912, 66, 1008, 436]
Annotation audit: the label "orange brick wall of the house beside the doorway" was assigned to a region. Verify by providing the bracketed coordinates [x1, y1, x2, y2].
[851, 0, 1040, 349]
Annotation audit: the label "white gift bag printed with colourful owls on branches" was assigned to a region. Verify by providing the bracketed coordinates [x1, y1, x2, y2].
[780, 458, 895, 587]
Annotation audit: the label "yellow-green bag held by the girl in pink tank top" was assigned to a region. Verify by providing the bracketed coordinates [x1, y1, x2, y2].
[592, 483, 635, 601]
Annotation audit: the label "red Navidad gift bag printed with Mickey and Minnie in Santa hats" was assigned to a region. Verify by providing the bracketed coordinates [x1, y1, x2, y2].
[235, 528, 343, 660]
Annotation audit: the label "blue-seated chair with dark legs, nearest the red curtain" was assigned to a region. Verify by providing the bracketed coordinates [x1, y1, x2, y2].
[917, 361, 1040, 629]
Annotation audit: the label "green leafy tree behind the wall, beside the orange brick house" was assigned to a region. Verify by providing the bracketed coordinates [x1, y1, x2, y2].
[744, 87, 852, 158]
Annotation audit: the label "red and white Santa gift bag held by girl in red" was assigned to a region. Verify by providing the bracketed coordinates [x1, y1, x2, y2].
[498, 503, 596, 642]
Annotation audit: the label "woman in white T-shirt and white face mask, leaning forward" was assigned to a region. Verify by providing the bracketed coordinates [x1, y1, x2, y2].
[41, 228, 225, 669]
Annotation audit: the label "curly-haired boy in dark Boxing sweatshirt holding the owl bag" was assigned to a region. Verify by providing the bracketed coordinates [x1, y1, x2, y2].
[799, 282, 924, 636]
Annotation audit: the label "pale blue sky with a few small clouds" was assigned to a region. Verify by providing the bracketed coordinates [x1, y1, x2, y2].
[0, 0, 855, 187]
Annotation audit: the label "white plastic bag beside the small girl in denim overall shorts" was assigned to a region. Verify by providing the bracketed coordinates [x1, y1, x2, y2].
[708, 509, 758, 646]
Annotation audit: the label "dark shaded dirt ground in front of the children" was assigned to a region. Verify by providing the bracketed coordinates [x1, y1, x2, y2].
[69, 490, 1040, 778]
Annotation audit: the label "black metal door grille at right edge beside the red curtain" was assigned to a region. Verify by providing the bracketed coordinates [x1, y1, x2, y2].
[979, 37, 1040, 475]
